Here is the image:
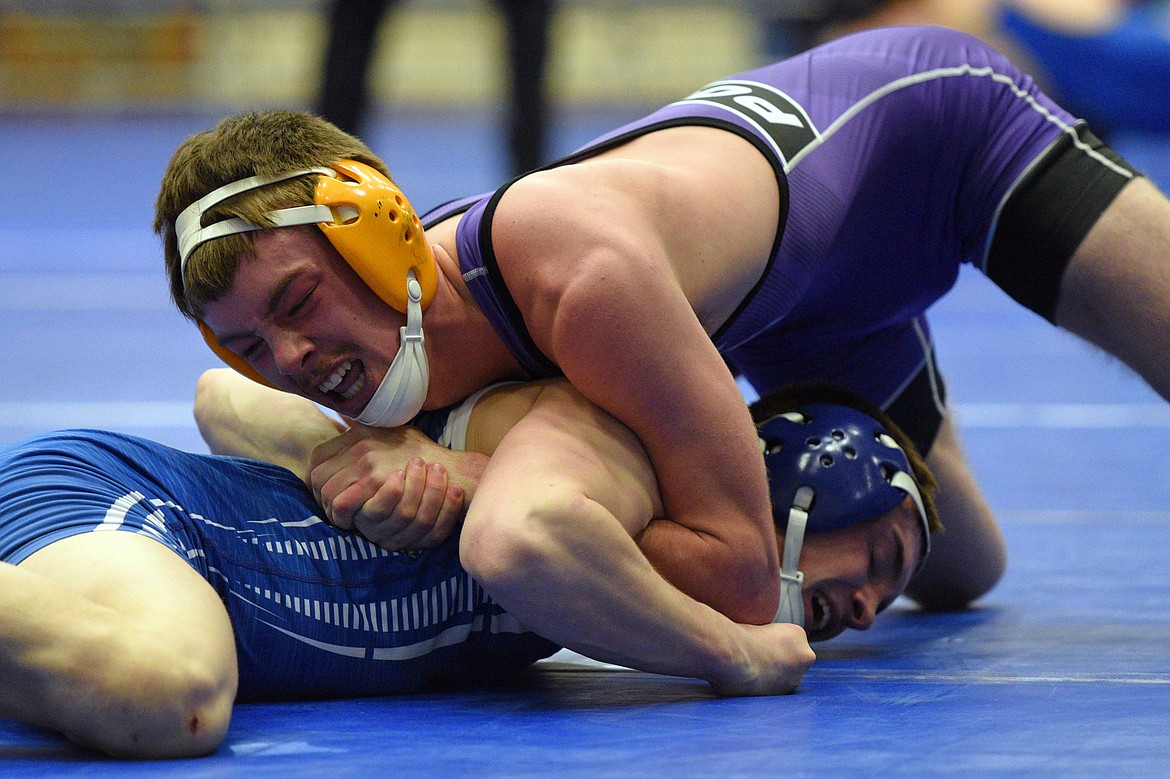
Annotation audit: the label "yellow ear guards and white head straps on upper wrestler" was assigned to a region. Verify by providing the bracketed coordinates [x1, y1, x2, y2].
[174, 160, 439, 385]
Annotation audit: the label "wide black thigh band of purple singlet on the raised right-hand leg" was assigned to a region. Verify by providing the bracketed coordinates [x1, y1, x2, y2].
[985, 124, 1137, 323]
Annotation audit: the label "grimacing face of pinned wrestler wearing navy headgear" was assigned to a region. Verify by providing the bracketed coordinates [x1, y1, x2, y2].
[795, 497, 924, 641]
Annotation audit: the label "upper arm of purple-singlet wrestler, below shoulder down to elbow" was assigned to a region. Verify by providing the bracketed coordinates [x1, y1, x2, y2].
[551, 251, 771, 536]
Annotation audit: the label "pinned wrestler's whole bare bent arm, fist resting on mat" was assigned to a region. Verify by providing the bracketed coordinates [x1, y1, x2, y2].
[460, 385, 813, 695]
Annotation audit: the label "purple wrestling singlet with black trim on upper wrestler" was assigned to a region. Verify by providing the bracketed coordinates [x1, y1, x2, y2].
[424, 28, 1134, 451]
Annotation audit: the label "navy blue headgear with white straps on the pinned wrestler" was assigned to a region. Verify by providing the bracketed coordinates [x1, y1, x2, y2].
[757, 404, 930, 625]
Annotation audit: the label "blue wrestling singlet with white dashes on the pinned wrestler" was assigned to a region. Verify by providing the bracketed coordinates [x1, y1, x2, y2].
[0, 430, 558, 699]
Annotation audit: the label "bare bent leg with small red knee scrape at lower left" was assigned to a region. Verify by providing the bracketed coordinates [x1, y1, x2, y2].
[0, 533, 236, 758]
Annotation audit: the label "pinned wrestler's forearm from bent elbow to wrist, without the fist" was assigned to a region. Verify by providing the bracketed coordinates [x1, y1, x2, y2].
[460, 496, 753, 681]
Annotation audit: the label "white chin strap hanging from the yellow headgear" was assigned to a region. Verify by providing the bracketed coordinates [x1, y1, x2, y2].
[357, 270, 431, 427]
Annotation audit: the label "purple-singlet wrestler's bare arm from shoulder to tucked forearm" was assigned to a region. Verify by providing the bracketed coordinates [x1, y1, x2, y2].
[494, 199, 779, 623]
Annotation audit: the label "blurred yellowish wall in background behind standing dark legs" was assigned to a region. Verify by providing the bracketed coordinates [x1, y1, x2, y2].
[0, 0, 761, 111]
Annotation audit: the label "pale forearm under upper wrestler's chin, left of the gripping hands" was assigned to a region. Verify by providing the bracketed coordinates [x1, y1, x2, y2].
[194, 368, 344, 483]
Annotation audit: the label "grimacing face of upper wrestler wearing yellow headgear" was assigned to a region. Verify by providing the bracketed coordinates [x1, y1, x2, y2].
[204, 226, 405, 418]
